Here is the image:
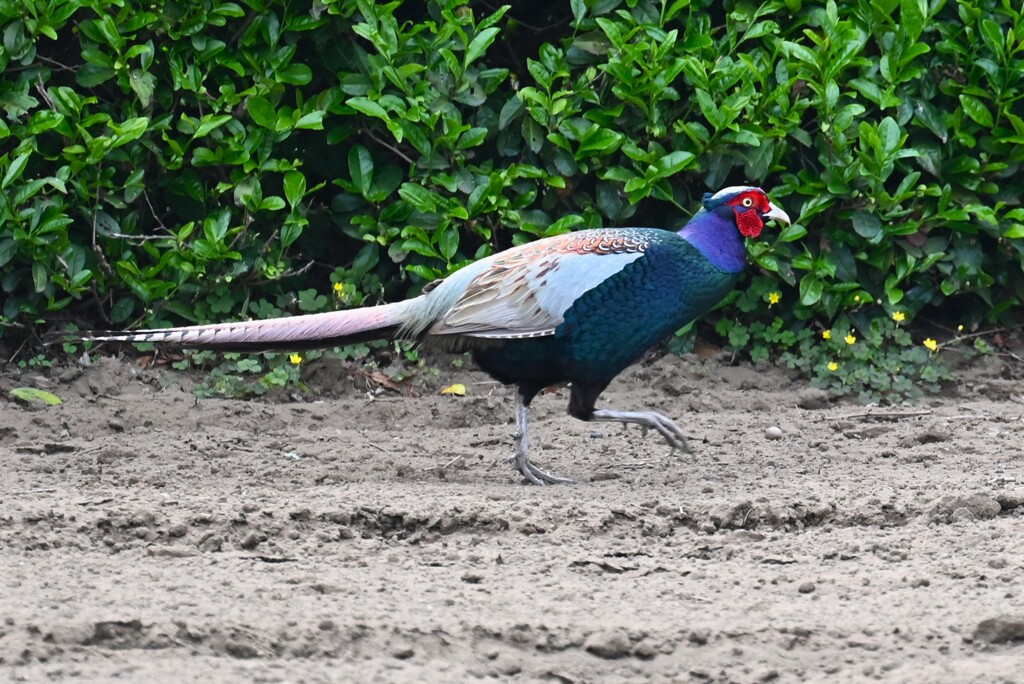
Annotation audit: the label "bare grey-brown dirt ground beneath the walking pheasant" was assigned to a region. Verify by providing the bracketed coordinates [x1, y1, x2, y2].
[0, 348, 1024, 683]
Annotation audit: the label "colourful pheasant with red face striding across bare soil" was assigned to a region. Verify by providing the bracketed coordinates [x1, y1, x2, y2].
[82, 186, 790, 484]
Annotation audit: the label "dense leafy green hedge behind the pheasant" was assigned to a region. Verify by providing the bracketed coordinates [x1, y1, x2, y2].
[0, 0, 1024, 378]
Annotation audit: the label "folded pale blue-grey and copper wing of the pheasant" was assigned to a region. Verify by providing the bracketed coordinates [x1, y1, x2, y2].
[429, 228, 649, 339]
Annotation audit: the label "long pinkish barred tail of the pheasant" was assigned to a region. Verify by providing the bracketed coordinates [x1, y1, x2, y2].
[78, 302, 407, 351]
